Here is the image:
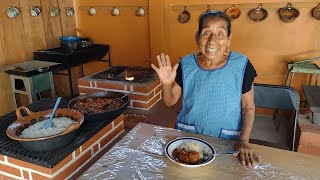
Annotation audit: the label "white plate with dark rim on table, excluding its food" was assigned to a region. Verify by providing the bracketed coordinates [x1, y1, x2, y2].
[165, 137, 216, 167]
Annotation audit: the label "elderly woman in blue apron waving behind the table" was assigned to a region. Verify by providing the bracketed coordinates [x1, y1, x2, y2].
[151, 11, 260, 167]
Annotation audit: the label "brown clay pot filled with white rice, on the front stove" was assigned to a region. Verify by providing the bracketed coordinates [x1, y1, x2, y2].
[6, 106, 84, 151]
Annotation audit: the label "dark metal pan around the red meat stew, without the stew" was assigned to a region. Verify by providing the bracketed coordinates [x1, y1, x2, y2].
[68, 91, 129, 121]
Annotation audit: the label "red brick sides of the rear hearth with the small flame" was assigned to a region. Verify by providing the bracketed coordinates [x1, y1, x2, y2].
[78, 78, 162, 110]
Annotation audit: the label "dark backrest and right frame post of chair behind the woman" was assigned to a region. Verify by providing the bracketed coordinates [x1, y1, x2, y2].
[254, 84, 300, 151]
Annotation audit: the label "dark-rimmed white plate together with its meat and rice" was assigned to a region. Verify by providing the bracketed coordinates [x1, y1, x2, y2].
[165, 137, 216, 167]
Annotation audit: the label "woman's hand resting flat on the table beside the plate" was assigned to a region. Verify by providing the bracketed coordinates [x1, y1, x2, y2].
[234, 141, 262, 168]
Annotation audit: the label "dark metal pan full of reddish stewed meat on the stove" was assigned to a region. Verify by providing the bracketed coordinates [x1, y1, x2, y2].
[68, 91, 129, 121]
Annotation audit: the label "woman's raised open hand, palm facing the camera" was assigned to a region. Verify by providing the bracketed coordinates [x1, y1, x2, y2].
[151, 53, 178, 85]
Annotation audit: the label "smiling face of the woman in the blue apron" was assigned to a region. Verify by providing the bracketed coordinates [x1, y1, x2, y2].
[197, 17, 231, 61]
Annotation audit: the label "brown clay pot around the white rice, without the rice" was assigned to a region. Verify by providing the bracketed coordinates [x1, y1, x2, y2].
[6, 106, 84, 151]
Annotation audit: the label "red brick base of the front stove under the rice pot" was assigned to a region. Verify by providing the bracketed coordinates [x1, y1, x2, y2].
[0, 115, 124, 180]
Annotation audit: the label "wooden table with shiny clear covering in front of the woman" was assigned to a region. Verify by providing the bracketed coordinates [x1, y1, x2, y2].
[79, 123, 320, 179]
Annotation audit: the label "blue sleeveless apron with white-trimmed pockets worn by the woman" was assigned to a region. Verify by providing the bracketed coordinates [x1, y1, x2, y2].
[176, 52, 247, 139]
